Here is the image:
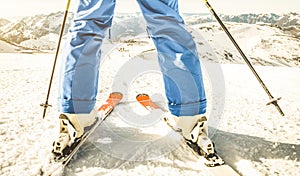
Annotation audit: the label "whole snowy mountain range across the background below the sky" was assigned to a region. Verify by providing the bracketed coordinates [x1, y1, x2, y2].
[0, 12, 300, 66]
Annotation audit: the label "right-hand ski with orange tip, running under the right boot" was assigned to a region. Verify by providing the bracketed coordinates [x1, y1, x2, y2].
[136, 94, 239, 176]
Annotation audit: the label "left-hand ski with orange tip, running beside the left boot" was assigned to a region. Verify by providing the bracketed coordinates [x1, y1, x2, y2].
[40, 92, 123, 176]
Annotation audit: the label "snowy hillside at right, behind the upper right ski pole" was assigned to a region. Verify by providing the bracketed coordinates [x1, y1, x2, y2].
[190, 22, 300, 66]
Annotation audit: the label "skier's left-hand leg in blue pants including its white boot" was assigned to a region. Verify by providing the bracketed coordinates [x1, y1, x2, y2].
[53, 0, 115, 156]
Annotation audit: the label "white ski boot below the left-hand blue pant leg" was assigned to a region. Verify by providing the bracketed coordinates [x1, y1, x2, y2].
[52, 110, 97, 161]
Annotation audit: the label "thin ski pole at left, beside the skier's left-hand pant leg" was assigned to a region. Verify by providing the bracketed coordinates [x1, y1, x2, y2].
[40, 0, 71, 118]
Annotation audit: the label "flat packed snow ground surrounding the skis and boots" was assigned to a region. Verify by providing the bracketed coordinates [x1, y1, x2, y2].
[0, 36, 300, 176]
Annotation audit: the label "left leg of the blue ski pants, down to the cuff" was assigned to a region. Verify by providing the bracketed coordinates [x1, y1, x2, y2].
[58, 0, 115, 114]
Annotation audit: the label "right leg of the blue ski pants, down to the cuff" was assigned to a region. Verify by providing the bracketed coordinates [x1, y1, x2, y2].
[137, 0, 206, 116]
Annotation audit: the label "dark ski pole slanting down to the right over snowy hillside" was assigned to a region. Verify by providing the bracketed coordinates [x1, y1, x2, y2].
[203, 0, 284, 116]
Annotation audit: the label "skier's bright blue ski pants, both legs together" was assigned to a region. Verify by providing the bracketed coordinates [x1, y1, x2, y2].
[58, 0, 206, 116]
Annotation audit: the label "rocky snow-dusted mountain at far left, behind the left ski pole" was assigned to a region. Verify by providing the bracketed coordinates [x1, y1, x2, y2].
[0, 12, 73, 50]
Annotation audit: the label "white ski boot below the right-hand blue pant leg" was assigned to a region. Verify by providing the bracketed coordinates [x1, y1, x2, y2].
[174, 115, 224, 167]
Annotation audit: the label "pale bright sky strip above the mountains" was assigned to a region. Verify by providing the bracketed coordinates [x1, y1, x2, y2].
[0, 0, 300, 18]
